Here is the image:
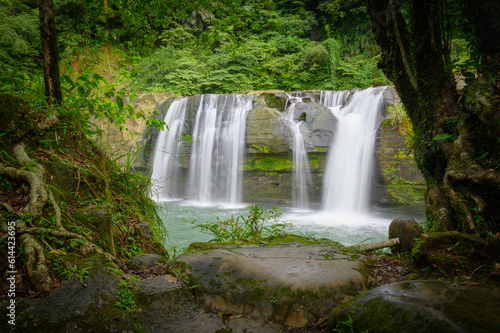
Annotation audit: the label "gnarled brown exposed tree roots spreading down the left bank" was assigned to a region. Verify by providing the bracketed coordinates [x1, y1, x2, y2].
[0, 143, 116, 291]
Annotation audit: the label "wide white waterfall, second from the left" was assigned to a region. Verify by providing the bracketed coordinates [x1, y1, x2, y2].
[188, 94, 253, 204]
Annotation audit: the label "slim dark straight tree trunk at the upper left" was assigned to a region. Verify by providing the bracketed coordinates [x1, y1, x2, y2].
[38, 0, 62, 105]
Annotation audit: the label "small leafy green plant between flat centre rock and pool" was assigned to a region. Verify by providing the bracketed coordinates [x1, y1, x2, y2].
[191, 205, 287, 242]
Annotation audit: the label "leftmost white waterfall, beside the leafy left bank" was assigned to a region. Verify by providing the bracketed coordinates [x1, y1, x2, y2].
[151, 98, 187, 200]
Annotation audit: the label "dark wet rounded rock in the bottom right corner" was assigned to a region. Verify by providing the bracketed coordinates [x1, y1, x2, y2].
[328, 281, 500, 333]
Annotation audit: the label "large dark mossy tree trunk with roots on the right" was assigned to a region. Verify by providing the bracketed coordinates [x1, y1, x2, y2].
[366, 0, 500, 233]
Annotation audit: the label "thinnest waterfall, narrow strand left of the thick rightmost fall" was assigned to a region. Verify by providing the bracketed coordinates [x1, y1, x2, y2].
[283, 95, 312, 209]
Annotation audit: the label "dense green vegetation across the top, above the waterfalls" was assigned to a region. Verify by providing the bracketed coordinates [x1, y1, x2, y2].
[0, 0, 389, 95]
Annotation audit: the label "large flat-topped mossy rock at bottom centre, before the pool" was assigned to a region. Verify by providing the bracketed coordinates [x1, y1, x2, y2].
[176, 243, 367, 327]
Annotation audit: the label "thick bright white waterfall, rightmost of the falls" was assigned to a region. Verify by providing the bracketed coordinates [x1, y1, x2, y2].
[322, 87, 386, 213]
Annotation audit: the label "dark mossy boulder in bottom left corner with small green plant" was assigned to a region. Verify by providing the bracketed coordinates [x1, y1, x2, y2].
[0, 263, 279, 333]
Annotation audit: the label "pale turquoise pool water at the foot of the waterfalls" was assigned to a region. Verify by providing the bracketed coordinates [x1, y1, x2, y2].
[158, 201, 425, 249]
